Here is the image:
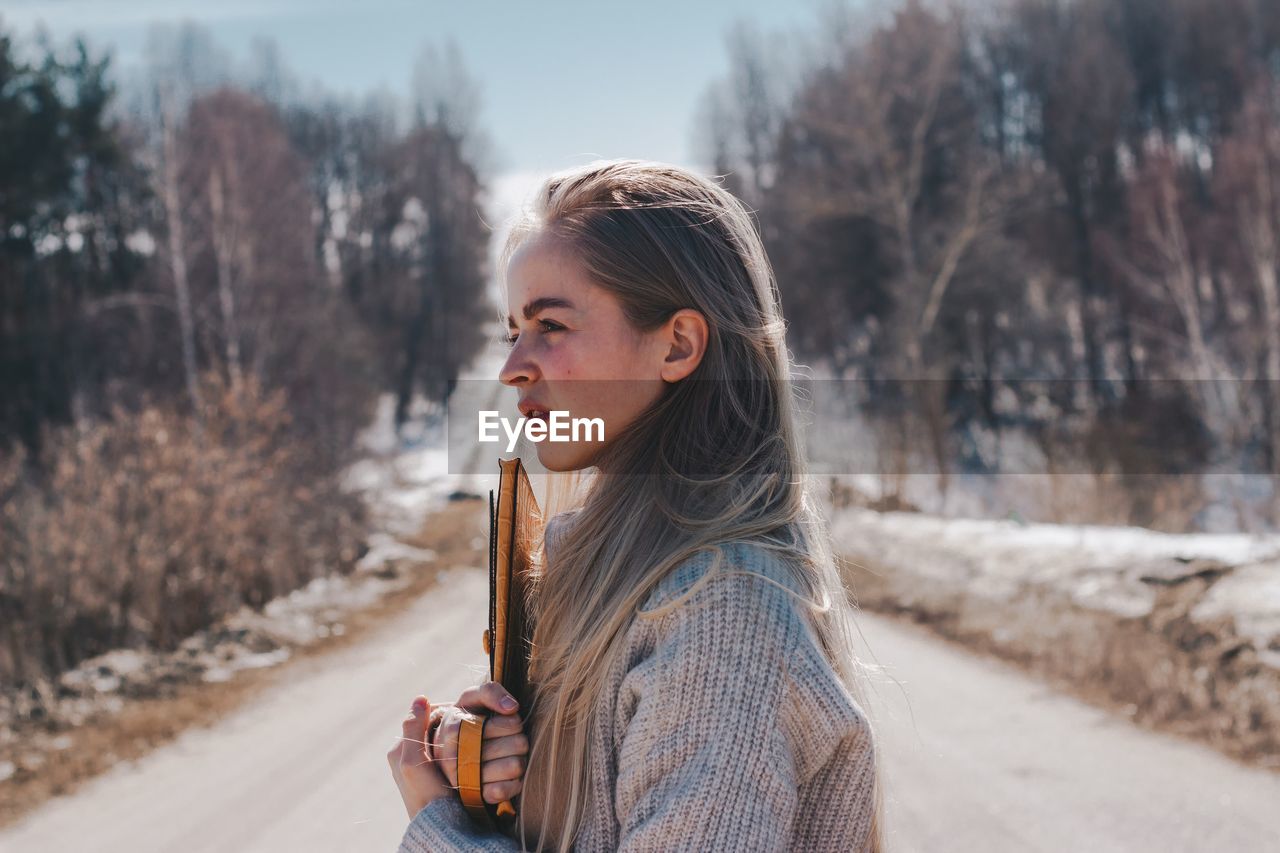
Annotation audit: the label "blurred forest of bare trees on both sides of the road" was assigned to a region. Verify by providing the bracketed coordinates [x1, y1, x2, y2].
[0, 0, 1280, 681]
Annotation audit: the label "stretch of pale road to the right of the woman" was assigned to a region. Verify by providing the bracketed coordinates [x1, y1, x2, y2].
[860, 615, 1280, 853]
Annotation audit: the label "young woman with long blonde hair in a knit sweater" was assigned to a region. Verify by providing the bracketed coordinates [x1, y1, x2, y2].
[388, 160, 883, 853]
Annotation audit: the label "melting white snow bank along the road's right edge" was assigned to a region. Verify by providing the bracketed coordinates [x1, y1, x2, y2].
[831, 499, 1280, 630]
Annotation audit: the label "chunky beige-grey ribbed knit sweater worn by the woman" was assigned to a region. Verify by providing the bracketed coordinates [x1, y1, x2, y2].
[398, 533, 877, 853]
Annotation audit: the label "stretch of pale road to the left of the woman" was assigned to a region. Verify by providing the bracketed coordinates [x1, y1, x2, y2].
[0, 567, 488, 853]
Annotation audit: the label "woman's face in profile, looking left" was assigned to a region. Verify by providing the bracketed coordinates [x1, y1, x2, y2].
[499, 233, 671, 471]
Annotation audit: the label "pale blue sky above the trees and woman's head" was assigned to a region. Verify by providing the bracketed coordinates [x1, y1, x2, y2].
[0, 0, 860, 284]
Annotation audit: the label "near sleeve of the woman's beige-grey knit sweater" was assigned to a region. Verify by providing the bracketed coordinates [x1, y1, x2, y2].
[614, 560, 803, 852]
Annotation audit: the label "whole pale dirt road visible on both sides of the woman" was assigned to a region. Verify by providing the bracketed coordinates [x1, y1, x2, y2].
[0, 567, 1280, 853]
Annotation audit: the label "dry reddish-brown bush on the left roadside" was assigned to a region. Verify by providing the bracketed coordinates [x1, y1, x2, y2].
[0, 374, 365, 684]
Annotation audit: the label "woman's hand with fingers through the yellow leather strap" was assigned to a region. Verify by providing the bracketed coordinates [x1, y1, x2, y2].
[430, 681, 529, 803]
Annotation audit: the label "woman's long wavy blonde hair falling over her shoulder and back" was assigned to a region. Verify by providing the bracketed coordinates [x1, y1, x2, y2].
[499, 160, 883, 852]
